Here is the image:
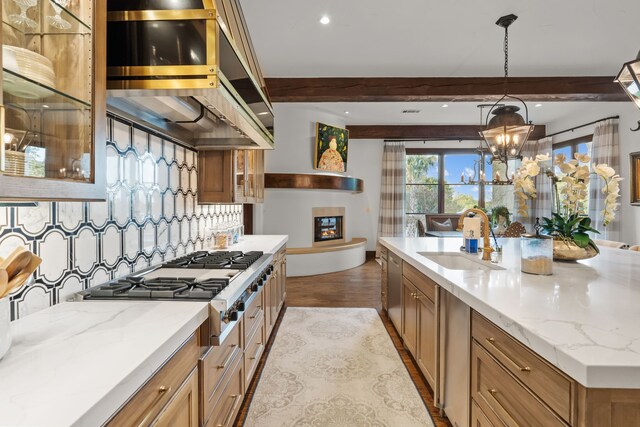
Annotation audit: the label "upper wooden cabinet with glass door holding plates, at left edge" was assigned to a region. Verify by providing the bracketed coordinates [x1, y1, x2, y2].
[0, 0, 106, 200]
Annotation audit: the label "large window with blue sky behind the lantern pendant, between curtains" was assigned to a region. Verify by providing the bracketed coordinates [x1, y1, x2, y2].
[405, 149, 515, 236]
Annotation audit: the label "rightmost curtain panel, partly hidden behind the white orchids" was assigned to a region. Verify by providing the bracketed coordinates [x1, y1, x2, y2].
[589, 119, 620, 241]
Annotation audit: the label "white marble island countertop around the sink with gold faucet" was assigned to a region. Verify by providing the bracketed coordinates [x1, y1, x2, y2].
[380, 237, 640, 388]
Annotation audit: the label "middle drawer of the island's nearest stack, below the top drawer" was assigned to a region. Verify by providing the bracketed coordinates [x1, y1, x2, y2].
[471, 341, 566, 427]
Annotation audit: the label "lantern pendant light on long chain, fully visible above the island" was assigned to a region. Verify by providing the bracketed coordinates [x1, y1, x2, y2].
[480, 14, 534, 163]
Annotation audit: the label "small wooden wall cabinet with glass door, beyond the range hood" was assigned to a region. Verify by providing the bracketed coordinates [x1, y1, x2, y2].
[198, 150, 264, 204]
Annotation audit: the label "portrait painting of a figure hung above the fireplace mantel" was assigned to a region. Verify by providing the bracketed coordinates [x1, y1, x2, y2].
[313, 122, 349, 172]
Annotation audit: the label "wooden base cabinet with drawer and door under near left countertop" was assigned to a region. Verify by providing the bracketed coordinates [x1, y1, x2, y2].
[107, 334, 199, 427]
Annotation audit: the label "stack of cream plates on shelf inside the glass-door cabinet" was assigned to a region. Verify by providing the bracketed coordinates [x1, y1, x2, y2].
[2, 45, 56, 99]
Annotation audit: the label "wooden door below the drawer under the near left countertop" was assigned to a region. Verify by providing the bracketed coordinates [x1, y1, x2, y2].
[151, 368, 198, 427]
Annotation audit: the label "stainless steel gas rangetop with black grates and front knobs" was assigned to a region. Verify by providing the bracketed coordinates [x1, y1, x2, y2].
[78, 251, 273, 345]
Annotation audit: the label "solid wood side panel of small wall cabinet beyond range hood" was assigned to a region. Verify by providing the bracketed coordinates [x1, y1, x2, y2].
[198, 150, 235, 204]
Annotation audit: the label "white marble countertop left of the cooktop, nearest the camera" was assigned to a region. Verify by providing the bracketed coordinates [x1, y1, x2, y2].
[0, 301, 209, 427]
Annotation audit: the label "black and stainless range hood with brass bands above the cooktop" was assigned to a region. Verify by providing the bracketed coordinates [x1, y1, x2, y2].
[107, 0, 273, 150]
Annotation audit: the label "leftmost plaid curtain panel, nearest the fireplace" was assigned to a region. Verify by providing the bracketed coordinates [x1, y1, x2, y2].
[376, 142, 406, 257]
